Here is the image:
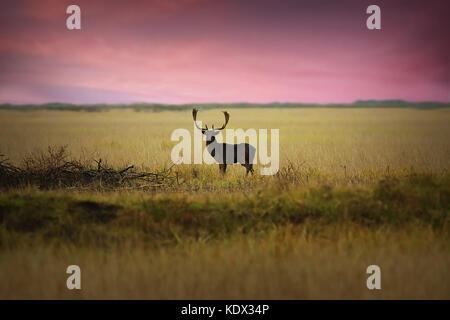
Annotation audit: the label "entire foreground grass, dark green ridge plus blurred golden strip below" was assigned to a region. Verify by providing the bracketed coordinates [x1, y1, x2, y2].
[0, 174, 450, 299]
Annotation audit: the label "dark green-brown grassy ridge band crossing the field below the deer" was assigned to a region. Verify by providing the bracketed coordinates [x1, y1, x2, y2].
[0, 174, 450, 248]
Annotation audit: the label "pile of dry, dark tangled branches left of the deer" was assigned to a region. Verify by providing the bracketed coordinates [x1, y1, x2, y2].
[0, 147, 177, 190]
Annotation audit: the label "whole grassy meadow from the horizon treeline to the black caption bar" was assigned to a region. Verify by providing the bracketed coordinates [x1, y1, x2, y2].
[0, 108, 450, 299]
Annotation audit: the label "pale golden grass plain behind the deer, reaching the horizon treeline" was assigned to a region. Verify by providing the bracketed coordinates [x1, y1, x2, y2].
[0, 109, 450, 177]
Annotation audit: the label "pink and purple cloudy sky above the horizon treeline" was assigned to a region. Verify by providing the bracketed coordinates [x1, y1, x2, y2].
[0, 0, 450, 104]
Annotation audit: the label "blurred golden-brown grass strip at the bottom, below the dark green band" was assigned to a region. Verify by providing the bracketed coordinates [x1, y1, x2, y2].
[0, 225, 450, 299]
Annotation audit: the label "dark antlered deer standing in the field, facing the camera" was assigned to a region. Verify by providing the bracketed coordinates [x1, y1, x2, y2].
[192, 108, 256, 175]
